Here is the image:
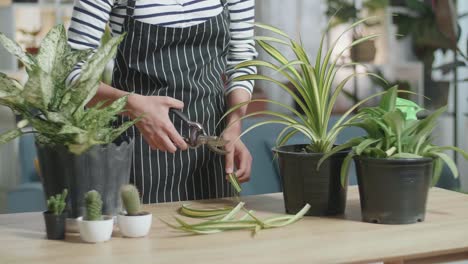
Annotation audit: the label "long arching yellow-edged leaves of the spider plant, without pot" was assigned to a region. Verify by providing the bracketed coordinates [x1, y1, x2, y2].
[225, 18, 388, 153]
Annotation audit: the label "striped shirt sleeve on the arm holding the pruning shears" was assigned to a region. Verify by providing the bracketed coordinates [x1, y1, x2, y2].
[66, 0, 114, 85]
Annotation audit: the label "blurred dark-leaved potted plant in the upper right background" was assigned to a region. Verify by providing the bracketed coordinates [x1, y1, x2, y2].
[393, 0, 464, 109]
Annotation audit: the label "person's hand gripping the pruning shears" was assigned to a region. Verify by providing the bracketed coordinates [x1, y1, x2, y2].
[127, 94, 188, 153]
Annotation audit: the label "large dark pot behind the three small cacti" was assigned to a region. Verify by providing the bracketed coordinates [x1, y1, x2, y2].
[36, 140, 133, 218]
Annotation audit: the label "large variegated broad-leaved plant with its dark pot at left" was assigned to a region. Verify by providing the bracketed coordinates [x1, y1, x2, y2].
[0, 25, 137, 221]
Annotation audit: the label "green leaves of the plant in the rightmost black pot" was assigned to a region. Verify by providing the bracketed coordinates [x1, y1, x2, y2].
[319, 87, 468, 185]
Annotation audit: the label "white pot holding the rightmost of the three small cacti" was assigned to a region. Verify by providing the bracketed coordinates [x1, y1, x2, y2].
[117, 212, 153, 237]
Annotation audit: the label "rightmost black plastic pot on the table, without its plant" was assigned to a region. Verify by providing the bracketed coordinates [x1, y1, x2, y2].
[354, 157, 433, 224]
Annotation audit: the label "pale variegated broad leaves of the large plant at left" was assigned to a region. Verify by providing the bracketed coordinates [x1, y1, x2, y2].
[0, 25, 137, 154]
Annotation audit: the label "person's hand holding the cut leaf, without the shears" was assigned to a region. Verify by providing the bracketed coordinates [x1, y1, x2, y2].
[223, 122, 252, 183]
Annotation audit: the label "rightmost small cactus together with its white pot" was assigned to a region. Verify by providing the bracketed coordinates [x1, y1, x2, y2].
[117, 184, 152, 237]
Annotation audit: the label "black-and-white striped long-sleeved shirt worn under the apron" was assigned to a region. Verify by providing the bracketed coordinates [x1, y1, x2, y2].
[67, 0, 257, 94]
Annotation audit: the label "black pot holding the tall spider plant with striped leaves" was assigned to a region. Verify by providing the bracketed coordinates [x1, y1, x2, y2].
[273, 144, 348, 216]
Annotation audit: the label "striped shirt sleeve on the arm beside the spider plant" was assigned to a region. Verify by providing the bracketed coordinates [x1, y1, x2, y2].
[226, 0, 258, 94]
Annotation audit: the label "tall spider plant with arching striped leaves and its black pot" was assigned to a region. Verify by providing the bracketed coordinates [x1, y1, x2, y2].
[226, 19, 386, 215]
